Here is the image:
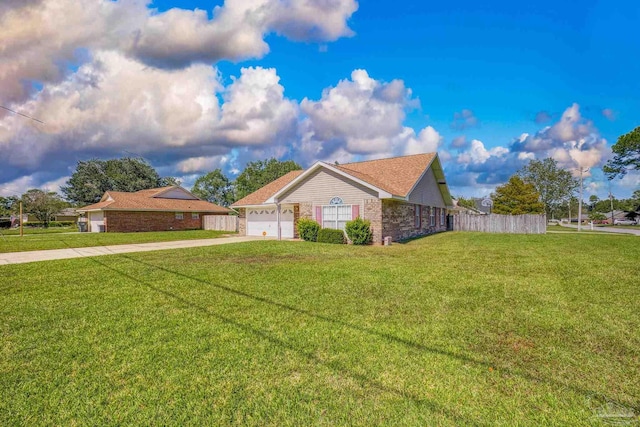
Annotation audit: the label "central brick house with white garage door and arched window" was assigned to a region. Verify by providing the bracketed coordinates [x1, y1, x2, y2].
[232, 153, 453, 243]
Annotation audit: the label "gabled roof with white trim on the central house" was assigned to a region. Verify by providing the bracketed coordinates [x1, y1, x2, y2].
[232, 153, 453, 206]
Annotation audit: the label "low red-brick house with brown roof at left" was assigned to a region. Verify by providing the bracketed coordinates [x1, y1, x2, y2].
[77, 185, 232, 233]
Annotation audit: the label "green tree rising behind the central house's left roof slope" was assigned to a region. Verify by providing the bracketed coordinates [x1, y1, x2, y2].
[234, 158, 302, 200]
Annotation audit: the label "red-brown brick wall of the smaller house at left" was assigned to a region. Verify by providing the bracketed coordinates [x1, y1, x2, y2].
[104, 211, 202, 232]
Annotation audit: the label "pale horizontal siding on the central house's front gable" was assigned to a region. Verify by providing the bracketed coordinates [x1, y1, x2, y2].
[280, 169, 378, 206]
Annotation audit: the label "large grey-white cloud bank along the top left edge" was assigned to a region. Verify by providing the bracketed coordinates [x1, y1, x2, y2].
[0, 0, 358, 102]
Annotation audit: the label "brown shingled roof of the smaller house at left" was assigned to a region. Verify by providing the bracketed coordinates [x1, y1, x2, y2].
[77, 186, 231, 213]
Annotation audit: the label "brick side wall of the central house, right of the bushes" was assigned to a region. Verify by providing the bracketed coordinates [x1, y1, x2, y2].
[382, 200, 447, 241]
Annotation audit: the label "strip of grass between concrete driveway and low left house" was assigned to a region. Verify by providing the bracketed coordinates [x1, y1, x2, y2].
[0, 230, 234, 253]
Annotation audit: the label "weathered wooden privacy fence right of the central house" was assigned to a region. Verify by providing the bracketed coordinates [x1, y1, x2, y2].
[453, 213, 547, 234]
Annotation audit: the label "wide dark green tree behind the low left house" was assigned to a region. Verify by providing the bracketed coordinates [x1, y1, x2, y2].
[61, 157, 164, 205]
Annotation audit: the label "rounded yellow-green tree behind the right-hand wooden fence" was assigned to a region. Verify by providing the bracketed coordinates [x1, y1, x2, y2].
[491, 175, 544, 215]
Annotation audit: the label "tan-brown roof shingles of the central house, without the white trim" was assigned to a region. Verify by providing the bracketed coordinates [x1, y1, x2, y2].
[232, 153, 450, 206]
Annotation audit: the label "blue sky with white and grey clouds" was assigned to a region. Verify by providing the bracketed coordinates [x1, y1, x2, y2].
[0, 0, 640, 199]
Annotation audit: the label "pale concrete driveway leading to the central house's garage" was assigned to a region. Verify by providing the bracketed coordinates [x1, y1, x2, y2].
[0, 236, 278, 265]
